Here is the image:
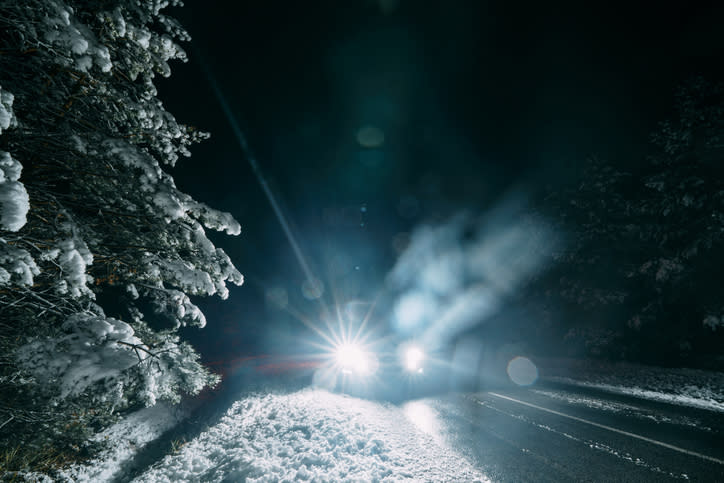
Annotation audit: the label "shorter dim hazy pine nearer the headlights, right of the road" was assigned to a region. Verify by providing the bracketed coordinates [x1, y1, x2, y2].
[528, 155, 636, 356]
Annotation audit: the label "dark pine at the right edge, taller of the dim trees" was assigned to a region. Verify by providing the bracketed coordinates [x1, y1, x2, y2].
[630, 77, 724, 362]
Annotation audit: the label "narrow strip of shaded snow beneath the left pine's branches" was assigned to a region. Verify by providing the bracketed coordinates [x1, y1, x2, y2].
[56, 402, 188, 482]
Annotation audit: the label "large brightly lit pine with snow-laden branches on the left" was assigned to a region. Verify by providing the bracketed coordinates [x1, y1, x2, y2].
[0, 0, 243, 464]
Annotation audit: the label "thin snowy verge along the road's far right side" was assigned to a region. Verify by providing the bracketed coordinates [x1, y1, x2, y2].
[535, 359, 724, 412]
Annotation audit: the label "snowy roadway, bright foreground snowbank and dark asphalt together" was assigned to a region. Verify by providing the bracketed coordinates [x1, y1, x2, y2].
[126, 384, 724, 482]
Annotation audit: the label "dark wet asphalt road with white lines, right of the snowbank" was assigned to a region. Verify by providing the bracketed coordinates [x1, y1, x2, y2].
[424, 385, 724, 482]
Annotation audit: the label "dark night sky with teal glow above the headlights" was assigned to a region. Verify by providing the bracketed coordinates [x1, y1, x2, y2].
[159, 0, 724, 364]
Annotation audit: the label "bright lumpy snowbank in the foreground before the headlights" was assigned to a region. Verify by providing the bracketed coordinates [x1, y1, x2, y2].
[134, 388, 489, 483]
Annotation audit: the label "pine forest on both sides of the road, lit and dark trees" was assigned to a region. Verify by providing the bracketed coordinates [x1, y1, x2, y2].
[0, 0, 724, 471]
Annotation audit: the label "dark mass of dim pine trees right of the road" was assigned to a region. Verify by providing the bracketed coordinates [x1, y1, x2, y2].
[539, 78, 724, 365]
